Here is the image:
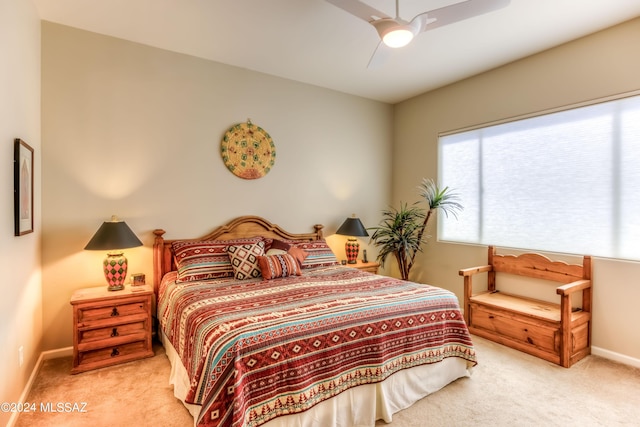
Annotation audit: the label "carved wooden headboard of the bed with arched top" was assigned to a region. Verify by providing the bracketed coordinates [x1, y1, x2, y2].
[153, 216, 324, 295]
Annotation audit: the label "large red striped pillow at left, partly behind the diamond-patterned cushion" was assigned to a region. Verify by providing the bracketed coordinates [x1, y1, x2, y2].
[171, 237, 263, 283]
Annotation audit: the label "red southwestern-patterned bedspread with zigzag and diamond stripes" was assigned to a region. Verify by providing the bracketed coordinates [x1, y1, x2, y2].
[158, 266, 476, 427]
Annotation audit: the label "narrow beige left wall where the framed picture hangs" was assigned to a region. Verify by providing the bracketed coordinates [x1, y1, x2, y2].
[0, 0, 42, 425]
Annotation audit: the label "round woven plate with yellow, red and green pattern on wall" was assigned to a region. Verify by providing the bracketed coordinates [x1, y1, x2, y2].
[220, 120, 276, 179]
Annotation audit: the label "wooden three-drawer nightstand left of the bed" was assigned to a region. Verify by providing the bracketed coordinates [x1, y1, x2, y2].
[71, 285, 154, 374]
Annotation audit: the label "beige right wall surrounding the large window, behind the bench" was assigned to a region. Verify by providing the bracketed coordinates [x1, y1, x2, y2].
[393, 19, 640, 363]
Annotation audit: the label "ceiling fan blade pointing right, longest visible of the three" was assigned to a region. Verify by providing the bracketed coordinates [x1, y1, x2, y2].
[411, 0, 511, 33]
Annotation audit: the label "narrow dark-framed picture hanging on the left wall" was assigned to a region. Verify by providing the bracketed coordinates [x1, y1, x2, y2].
[13, 138, 33, 236]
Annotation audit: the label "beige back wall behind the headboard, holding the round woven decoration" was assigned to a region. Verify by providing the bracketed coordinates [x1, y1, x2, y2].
[42, 22, 393, 349]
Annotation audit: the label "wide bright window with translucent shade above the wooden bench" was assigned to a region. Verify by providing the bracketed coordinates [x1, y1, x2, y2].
[438, 96, 640, 260]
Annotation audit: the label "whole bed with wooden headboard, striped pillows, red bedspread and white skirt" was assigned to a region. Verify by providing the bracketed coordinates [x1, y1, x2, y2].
[154, 216, 476, 427]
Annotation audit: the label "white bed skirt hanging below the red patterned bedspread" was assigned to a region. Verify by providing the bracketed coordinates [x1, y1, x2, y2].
[160, 331, 471, 427]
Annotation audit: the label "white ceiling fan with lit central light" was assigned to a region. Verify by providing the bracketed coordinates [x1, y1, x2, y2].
[327, 0, 511, 67]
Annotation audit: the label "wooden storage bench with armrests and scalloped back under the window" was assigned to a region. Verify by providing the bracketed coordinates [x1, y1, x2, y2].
[459, 246, 592, 368]
